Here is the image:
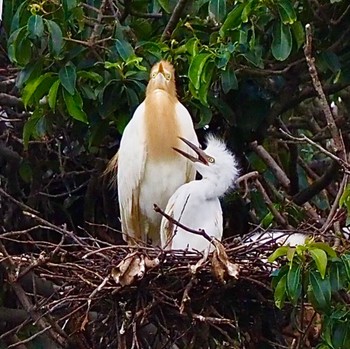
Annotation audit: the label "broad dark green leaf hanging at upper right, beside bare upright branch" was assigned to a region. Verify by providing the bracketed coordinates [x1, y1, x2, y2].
[271, 21, 292, 61]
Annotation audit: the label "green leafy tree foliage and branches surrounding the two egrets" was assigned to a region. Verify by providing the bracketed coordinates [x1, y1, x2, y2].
[0, 0, 350, 348]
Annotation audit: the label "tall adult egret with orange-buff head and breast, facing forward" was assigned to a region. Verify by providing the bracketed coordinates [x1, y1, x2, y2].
[111, 61, 198, 245]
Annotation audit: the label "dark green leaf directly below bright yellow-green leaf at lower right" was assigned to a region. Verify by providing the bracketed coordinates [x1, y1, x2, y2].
[309, 271, 331, 310]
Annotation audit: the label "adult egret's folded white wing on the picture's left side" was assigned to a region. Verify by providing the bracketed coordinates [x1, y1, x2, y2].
[117, 102, 146, 242]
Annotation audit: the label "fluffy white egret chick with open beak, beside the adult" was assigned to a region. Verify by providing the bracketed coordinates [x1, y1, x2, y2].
[161, 136, 239, 251]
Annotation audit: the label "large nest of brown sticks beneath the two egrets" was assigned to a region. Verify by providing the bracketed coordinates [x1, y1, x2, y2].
[0, 218, 330, 348]
